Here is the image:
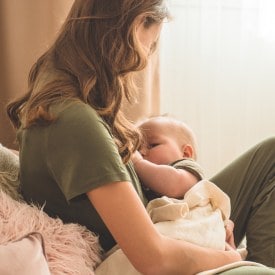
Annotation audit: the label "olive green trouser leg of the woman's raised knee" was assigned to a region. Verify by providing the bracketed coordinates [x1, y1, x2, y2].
[211, 137, 275, 267]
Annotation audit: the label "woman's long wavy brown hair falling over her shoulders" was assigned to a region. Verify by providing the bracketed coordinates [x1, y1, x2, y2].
[7, 0, 168, 163]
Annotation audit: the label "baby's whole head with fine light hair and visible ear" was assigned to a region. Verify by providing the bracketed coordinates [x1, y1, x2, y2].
[138, 116, 197, 164]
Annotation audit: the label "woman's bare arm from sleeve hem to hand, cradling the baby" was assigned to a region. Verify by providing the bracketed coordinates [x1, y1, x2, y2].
[87, 182, 243, 275]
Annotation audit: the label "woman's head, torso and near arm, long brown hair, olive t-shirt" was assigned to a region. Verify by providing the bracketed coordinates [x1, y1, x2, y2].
[8, 0, 275, 274]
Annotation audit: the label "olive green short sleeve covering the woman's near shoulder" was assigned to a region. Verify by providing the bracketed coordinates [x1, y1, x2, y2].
[47, 103, 131, 200]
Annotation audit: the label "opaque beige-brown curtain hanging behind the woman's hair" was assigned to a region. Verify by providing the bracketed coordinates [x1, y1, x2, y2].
[0, 0, 159, 149]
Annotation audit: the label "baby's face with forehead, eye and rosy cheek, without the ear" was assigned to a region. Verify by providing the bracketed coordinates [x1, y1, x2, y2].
[140, 121, 183, 164]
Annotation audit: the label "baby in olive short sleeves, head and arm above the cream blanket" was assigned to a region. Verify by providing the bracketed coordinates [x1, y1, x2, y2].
[136, 116, 204, 200]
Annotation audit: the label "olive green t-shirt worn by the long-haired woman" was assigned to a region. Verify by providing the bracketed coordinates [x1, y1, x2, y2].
[18, 102, 146, 250]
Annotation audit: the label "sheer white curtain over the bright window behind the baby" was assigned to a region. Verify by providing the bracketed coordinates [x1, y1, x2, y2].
[160, 0, 275, 176]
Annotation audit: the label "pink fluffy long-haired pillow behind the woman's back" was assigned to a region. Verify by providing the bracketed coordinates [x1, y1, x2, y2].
[0, 190, 101, 275]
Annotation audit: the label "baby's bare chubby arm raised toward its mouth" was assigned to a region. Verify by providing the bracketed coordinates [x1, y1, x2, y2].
[132, 152, 198, 198]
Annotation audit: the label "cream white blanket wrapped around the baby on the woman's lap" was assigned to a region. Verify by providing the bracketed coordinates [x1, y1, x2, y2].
[95, 180, 266, 275]
